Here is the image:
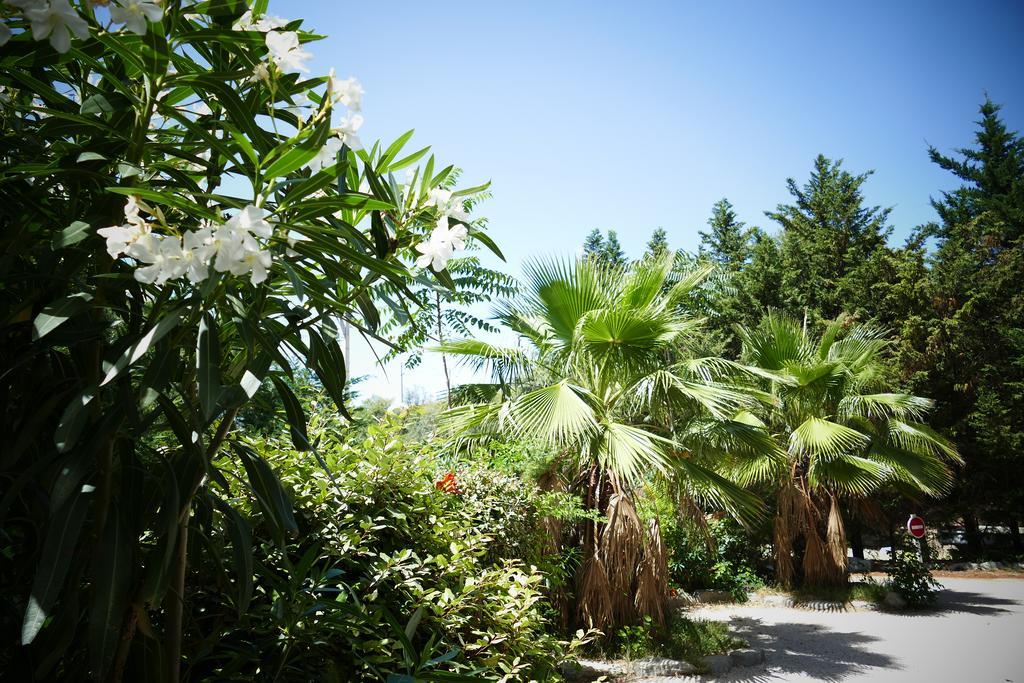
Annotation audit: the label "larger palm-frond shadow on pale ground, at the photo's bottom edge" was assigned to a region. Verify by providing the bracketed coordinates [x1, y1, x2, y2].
[720, 616, 900, 682]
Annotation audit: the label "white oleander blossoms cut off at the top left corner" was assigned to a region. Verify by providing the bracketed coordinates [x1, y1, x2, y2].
[0, 0, 164, 53]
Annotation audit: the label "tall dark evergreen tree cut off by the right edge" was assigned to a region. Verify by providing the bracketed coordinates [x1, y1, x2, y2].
[901, 99, 1024, 552]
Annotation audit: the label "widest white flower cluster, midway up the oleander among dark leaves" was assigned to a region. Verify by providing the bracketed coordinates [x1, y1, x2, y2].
[96, 197, 273, 285]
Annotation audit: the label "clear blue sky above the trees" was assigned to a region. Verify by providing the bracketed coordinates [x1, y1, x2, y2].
[282, 0, 1024, 397]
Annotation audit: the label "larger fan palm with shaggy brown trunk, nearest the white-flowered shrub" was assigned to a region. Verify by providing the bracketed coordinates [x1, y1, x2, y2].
[441, 255, 774, 633]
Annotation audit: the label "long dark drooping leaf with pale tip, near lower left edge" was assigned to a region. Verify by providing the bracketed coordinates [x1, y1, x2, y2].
[22, 485, 94, 645]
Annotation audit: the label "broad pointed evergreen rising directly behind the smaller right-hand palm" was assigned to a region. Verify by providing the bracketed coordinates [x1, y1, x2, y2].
[766, 155, 892, 319]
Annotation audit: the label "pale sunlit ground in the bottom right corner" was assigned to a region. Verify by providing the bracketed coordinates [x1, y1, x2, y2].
[643, 577, 1024, 683]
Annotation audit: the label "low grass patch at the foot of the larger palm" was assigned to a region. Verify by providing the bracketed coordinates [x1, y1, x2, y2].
[600, 615, 746, 664]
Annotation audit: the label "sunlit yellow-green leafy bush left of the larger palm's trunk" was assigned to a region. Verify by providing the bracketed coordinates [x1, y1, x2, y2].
[182, 426, 593, 681]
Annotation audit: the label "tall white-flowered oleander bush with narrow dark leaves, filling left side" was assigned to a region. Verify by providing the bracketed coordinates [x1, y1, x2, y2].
[0, 0, 503, 682]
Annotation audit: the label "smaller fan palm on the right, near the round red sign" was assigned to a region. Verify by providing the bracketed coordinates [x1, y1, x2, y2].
[735, 313, 961, 586]
